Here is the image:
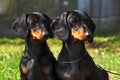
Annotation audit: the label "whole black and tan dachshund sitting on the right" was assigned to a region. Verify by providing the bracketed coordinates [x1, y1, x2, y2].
[51, 10, 108, 80]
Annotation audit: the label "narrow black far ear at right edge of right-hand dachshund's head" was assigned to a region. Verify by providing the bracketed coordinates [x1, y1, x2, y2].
[83, 12, 96, 43]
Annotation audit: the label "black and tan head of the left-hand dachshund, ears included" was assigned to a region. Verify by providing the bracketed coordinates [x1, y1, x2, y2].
[12, 12, 53, 42]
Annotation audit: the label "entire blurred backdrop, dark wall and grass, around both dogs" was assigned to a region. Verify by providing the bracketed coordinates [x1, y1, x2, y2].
[0, 0, 120, 80]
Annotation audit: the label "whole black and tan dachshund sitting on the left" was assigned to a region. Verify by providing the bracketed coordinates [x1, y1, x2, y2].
[13, 12, 55, 80]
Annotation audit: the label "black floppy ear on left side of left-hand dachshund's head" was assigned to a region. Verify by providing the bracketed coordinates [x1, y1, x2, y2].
[12, 15, 28, 38]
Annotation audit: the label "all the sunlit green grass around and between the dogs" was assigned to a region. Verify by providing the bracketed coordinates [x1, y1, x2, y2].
[0, 35, 120, 80]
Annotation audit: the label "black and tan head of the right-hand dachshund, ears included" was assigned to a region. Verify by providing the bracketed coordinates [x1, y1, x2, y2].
[51, 10, 95, 42]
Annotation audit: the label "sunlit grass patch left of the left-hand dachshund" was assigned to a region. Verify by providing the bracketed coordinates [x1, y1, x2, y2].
[0, 38, 24, 80]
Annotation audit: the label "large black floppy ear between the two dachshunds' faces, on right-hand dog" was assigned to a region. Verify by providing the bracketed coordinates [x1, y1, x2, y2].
[51, 12, 69, 41]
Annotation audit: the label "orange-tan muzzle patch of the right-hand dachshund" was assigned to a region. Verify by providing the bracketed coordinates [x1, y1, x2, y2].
[71, 28, 87, 40]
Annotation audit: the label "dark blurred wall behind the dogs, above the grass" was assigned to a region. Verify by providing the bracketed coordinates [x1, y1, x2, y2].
[0, 0, 120, 37]
